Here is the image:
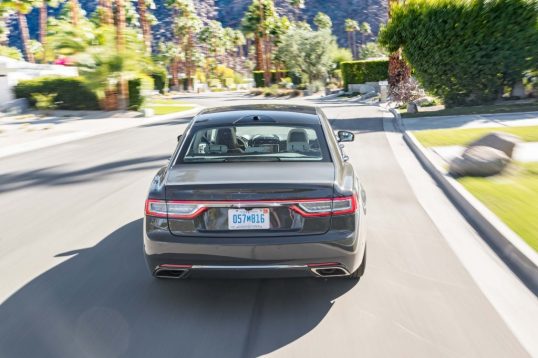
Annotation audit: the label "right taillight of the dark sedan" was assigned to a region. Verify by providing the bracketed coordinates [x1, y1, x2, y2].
[291, 195, 357, 217]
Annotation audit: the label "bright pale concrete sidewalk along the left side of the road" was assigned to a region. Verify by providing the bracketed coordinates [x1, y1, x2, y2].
[0, 105, 202, 158]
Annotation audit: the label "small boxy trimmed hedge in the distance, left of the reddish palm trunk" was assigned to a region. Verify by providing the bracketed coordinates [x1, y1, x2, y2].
[340, 60, 389, 91]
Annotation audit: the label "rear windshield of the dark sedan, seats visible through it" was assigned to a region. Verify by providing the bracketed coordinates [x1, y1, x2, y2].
[179, 124, 330, 163]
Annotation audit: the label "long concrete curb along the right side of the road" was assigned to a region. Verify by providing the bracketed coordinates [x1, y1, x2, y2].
[389, 108, 538, 296]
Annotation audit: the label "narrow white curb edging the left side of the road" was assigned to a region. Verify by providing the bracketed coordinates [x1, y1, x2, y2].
[0, 106, 204, 159]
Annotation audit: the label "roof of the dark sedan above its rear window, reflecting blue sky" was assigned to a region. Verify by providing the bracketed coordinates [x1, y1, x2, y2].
[193, 104, 321, 126]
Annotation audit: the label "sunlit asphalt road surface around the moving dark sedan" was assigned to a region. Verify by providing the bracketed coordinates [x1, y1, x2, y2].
[0, 98, 528, 358]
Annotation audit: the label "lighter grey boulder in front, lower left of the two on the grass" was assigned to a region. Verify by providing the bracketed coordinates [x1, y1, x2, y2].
[449, 146, 510, 177]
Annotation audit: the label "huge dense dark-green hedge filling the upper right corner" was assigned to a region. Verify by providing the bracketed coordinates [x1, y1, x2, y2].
[380, 0, 538, 106]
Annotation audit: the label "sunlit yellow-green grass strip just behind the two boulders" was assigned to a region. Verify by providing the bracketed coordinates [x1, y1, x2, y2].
[413, 126, 538, 147]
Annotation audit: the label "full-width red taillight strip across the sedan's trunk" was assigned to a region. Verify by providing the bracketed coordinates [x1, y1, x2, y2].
[145, 195, 358, 219]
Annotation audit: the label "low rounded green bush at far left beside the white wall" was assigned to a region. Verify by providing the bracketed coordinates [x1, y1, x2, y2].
[14, 77, 99, 110]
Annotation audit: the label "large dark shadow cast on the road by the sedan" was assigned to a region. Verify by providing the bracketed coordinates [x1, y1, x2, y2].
[0, 219, 356, 358]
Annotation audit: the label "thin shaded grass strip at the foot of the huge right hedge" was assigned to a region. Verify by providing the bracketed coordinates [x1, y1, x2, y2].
[399, 102, 538, 118]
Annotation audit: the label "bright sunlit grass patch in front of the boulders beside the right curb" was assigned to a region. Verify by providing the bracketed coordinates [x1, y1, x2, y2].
[458, 162, 538, 251]
